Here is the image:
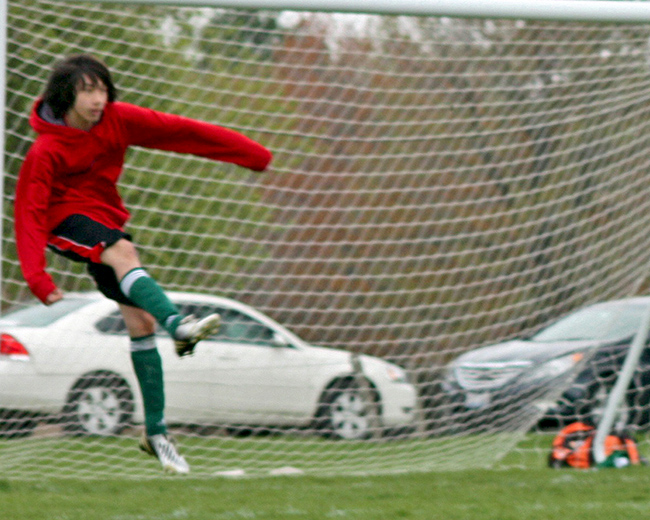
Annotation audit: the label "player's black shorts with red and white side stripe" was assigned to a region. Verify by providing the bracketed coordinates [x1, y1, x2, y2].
[47, 215, 136, 306]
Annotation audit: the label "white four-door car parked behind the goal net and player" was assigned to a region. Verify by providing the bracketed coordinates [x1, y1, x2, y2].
[0, 292, 416, 439]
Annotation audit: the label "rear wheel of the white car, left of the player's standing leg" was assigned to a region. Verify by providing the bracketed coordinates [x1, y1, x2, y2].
[62, 371, 134, 437]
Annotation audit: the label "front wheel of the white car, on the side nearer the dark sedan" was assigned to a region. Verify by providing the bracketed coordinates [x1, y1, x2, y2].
[316, 378, 381, 440]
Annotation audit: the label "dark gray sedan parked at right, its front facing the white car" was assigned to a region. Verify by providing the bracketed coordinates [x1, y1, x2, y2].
[442, 297, 650, 429]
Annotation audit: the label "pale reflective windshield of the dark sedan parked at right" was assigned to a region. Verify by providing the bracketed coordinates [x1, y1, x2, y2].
[530, 303, 647, 342]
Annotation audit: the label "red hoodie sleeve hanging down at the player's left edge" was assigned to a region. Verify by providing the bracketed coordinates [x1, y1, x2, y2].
[14, 147, 56, 303]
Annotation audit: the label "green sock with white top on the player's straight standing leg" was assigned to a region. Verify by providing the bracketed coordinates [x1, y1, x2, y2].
[131, 336, 167, 436]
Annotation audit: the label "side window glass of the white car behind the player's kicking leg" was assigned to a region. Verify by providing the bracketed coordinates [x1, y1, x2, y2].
[95, 303, 274, 346]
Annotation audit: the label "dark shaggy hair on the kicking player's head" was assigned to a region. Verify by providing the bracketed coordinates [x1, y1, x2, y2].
[43, 54, 117, 117]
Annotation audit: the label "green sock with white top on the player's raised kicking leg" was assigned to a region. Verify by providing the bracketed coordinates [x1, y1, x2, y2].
[120, 267, 182, 337]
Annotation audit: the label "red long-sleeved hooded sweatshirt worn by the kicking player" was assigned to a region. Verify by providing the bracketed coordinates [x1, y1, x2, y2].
[15, 100, 272, 302]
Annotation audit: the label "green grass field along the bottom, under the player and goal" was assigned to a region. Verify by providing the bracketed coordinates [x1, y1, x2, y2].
[0, 435, 650, 520]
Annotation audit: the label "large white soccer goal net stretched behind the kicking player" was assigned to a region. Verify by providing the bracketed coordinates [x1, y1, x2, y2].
[0, 0, 650, 478]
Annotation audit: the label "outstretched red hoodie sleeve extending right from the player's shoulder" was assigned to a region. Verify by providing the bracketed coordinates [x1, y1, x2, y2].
[115, 103, 272, 171]
